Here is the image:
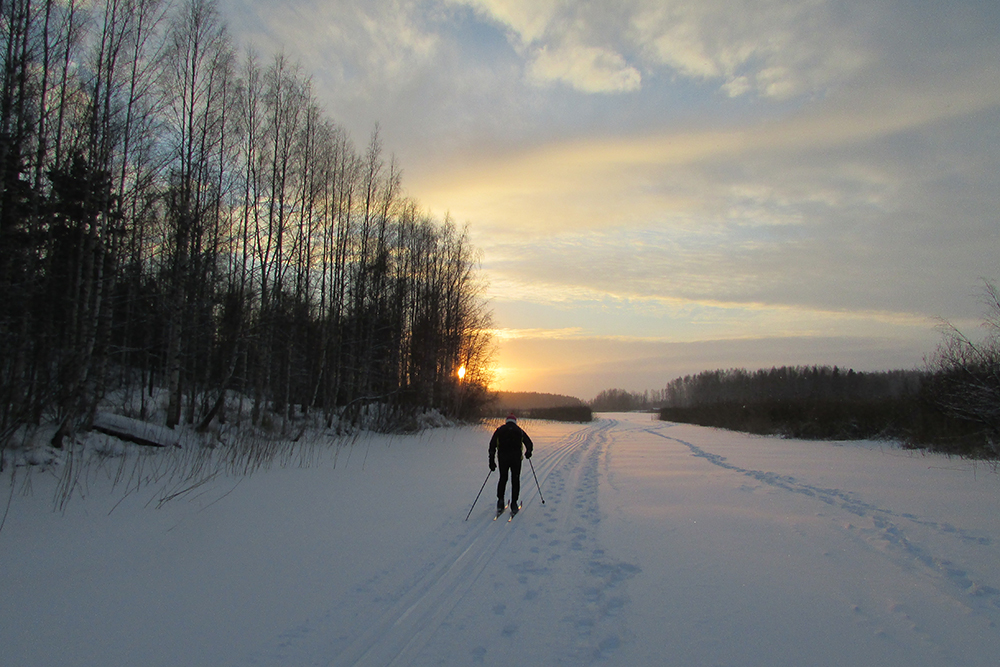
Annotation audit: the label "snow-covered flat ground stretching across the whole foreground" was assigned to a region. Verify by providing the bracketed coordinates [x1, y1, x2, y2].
[0, 414, 1000, 667]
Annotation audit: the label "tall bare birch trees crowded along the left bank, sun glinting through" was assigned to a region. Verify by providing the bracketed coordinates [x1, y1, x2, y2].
[0, 0, 492, 454]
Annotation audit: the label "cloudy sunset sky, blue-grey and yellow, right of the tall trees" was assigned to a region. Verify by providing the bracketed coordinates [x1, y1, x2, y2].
[220, 0, 1000, 400]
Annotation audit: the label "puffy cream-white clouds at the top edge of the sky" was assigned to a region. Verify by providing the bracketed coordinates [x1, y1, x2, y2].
[452, 0, 867, 99]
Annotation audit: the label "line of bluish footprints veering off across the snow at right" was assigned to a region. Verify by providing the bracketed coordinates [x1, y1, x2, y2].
[644, 423, 1000, 619]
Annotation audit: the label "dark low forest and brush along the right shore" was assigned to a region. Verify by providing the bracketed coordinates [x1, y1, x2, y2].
[589, 292, 1000, 459]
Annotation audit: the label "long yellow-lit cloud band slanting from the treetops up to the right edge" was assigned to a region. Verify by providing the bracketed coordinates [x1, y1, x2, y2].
[412, 56, 1000, 234]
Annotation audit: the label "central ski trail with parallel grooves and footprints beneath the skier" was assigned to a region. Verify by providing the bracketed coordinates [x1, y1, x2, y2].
[325, 420, 638, 666]
